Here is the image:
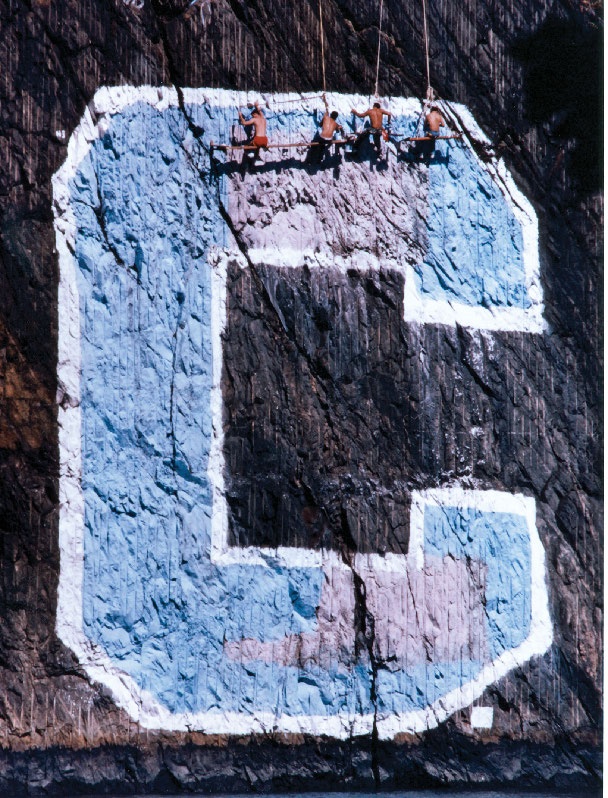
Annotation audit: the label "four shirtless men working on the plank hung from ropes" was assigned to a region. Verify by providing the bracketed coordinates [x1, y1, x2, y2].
[234, 95, 445, 164]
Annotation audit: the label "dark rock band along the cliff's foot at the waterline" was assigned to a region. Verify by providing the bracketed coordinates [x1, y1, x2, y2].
[0, 732, 601, 798]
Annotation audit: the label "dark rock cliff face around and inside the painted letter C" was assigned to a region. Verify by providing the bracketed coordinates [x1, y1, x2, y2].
[0, 0, 602, 794]
